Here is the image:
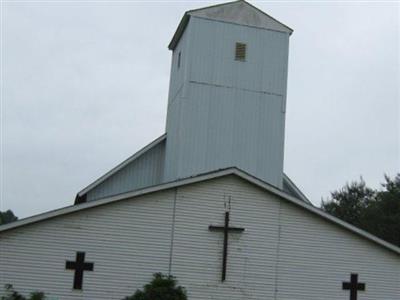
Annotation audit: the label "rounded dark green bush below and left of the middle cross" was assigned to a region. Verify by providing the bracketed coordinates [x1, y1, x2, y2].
[124, 273, 187, 300]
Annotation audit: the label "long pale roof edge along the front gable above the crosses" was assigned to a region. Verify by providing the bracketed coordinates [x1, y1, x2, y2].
[0, 168, 400, 255]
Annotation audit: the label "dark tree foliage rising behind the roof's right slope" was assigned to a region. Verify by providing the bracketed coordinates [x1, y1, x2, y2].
[321, 173, 400, 246]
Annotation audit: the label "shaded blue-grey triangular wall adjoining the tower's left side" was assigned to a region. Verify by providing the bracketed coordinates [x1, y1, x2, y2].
[87, 140, 166, 201]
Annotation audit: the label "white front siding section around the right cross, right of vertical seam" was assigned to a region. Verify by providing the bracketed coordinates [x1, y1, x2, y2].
[277, 198, 400, 300]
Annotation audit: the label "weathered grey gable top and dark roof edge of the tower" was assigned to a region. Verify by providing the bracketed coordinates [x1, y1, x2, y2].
[168, 0, 293, 50]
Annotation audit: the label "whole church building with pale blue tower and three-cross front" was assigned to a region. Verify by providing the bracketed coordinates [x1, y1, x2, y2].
[0, 1, 400, 300]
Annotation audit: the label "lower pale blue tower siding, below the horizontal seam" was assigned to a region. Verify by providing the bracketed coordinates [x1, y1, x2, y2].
[166, 83, 284, 186]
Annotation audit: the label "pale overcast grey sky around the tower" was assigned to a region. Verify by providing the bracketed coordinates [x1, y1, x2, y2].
[0, 1, 400, 217]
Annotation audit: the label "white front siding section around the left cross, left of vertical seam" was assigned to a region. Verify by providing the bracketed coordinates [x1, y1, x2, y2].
[0, 191, 174, 300]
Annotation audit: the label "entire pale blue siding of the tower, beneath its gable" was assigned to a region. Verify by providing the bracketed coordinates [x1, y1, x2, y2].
[165, 17, 289, 188]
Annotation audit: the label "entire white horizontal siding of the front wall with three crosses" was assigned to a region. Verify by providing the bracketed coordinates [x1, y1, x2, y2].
[0, 176, 400, 300]
